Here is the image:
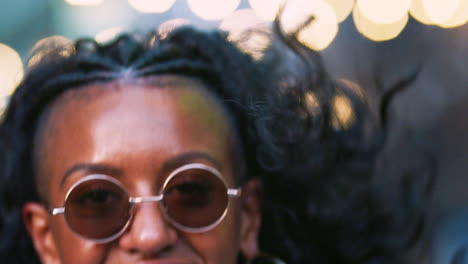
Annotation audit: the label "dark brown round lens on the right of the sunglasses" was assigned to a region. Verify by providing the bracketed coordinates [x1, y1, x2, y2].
[163, 168, 228, 228]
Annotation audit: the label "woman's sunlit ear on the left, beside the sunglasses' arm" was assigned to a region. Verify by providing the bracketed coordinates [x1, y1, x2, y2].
[23, 202, 60, 263]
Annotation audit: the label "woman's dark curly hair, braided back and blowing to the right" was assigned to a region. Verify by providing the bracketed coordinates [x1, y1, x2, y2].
[0, 23, 416, 263]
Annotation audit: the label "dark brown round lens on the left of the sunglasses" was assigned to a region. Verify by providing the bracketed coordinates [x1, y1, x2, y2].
[65, 179, 131, 239]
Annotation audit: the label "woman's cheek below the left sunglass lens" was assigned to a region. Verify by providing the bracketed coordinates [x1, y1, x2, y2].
[52, 216, 111, 264]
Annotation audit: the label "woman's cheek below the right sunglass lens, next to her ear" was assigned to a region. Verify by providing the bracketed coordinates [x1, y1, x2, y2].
[183, 201, 241, 264]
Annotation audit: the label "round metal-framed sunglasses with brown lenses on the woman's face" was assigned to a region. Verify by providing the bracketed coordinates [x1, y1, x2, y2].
[50, 163, 241, 243]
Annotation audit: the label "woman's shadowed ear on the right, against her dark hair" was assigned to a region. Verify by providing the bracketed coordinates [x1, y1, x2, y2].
[240, 179, 262, 260]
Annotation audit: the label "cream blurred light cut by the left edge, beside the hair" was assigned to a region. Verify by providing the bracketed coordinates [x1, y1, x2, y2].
[0, 43, 24, 97]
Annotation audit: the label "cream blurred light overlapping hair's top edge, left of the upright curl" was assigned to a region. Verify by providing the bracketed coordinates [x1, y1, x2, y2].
[219, 9, 271, 60]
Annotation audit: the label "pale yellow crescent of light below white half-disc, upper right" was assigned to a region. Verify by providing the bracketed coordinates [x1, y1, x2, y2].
[353, 4, 409, 41]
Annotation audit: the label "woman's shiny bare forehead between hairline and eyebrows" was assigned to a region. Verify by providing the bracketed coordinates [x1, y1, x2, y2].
[35, 77, 235, 194]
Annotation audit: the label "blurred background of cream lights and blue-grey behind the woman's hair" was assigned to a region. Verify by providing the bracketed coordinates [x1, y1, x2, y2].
[0, 0, 468, 264]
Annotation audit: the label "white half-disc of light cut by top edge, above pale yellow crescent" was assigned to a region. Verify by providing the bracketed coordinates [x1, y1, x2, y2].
[354, 0, 411, 24]
